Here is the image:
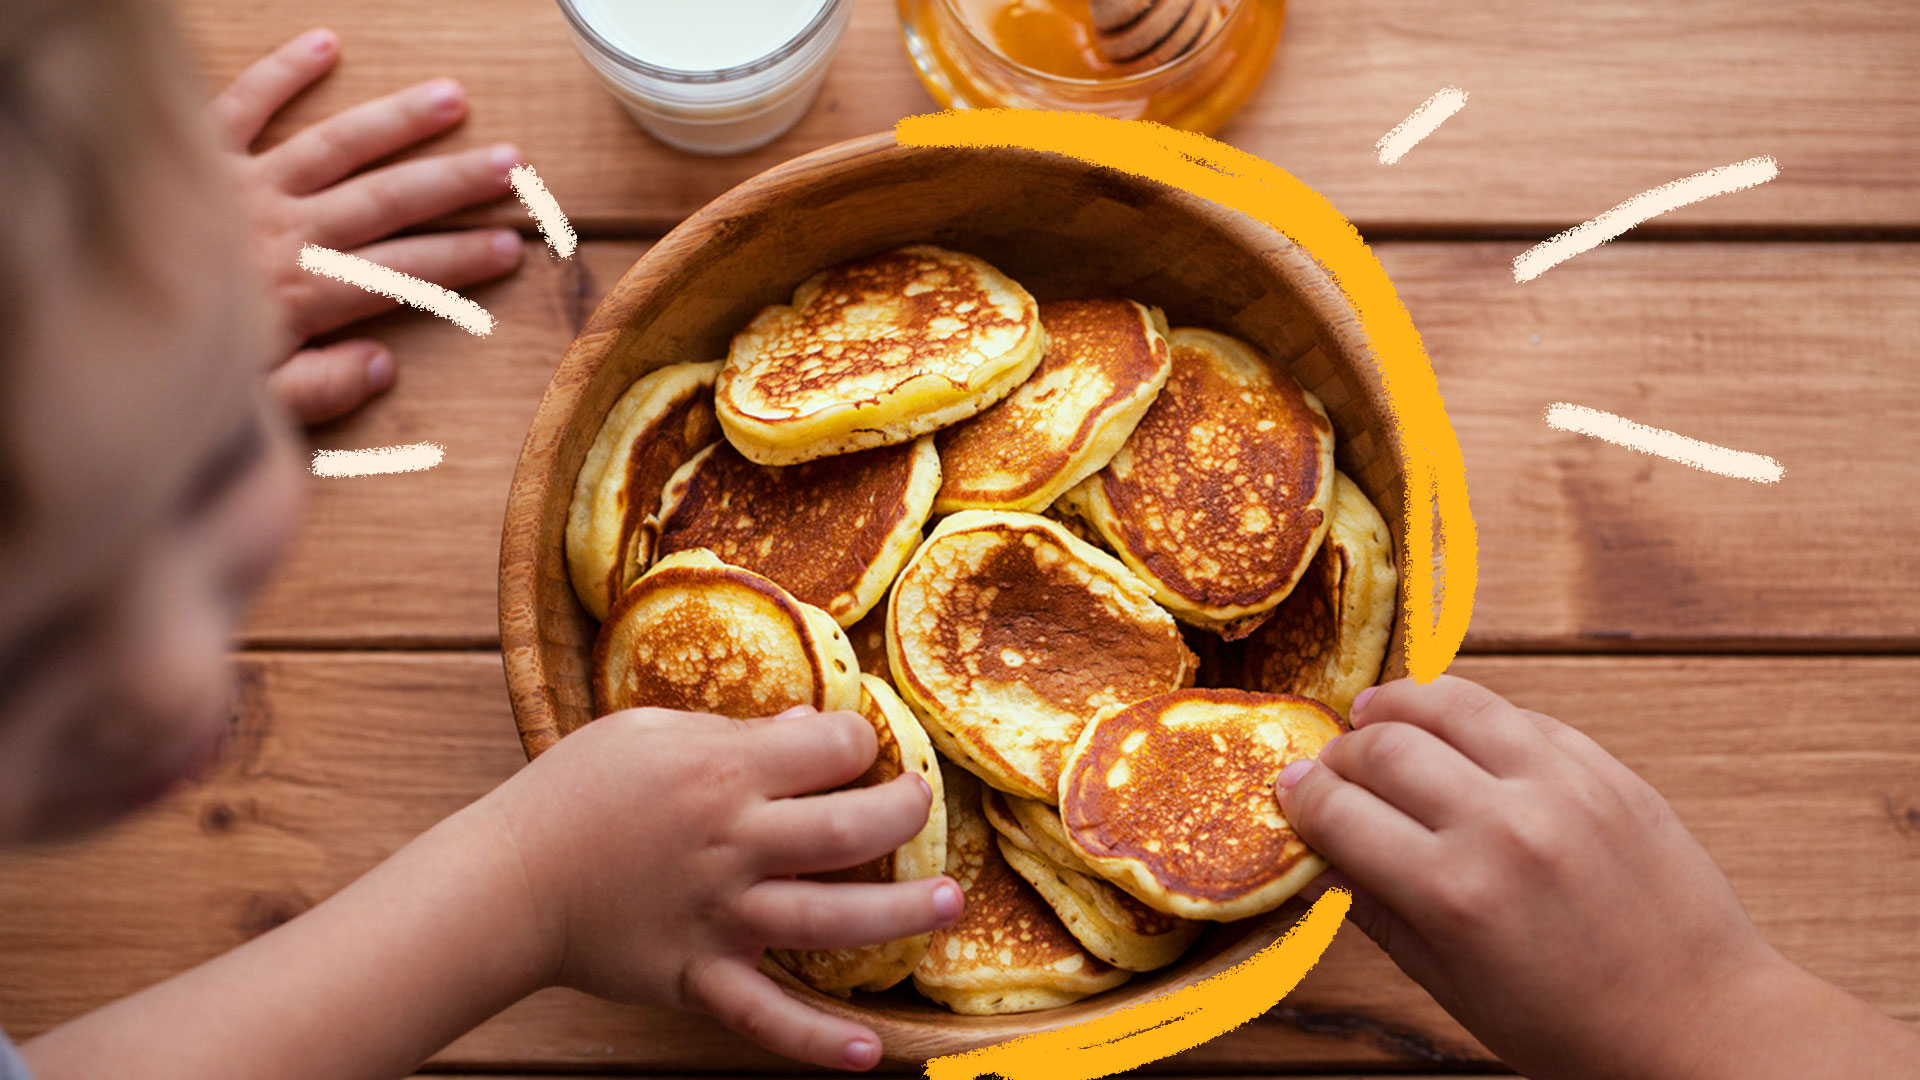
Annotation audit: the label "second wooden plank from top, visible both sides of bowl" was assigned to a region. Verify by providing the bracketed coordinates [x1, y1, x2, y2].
[236, 242, 1920, 650]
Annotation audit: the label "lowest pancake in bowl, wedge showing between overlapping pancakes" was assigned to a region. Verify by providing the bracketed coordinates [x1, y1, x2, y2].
[914, 769, 1131, 1015]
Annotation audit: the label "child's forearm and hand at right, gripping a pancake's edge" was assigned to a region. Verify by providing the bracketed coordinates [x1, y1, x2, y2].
[1281, 676, 1920, 1080]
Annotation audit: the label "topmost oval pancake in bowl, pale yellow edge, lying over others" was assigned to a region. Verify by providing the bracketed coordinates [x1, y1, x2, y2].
[714, 244, 1044, 465]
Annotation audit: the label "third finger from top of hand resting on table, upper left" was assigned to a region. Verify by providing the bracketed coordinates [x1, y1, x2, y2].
[305, 144, 520, 248]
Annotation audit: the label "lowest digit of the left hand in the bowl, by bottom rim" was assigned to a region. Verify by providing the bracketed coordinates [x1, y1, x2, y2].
[685, 959, 879, 1070]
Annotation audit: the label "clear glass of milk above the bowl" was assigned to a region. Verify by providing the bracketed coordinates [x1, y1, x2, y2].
[559, 0, 851, 154]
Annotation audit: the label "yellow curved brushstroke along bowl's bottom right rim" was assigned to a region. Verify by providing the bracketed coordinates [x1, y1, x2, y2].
[927, 888, 1354, 1080]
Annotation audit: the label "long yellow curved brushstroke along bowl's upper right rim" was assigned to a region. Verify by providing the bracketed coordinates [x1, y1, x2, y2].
[893, 110, 1478, 682]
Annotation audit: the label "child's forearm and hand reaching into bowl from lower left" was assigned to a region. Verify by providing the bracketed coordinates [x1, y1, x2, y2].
[23, 709, 962, 1080]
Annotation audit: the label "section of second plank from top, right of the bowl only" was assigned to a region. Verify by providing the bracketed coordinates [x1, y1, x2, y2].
[1379, 244, 1920, 650]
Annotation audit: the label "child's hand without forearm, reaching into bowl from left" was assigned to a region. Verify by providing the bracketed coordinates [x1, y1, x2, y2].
[499, 709, 962, 1068]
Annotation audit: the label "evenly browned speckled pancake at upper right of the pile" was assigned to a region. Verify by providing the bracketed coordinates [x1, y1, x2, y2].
[1068, 329, 1332, 640]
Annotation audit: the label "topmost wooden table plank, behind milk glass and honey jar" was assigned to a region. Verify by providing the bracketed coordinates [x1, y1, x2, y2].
[180, 0, 1920, 234]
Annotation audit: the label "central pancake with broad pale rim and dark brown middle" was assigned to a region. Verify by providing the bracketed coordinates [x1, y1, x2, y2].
[887, 509, 1194, 801]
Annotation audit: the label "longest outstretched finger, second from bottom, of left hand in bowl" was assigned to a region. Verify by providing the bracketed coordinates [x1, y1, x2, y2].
[739, 876, 966, 949]
